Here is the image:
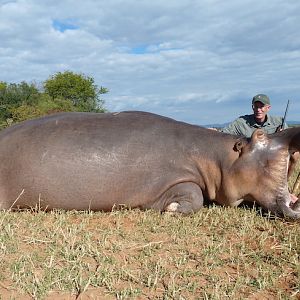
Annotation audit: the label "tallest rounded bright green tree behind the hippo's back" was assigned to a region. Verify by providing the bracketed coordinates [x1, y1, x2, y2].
[44, 71, 108, 112]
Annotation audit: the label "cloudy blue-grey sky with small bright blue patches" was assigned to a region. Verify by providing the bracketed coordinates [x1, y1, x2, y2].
[0, 0, 300, 125]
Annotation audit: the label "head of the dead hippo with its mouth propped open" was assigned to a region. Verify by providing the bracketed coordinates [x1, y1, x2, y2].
[231, 128, 300, 219]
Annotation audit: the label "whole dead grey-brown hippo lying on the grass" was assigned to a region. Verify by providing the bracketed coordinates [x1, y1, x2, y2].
[0, 112, 300, 219]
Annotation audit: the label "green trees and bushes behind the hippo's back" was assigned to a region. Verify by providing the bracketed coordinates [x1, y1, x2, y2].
[0, 71, 108, 128]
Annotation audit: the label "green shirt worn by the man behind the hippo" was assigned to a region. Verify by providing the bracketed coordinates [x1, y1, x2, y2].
[221, 114, 288, 138]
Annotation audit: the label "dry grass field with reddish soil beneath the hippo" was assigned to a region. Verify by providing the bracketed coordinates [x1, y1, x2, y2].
[0, 165, 300, 299]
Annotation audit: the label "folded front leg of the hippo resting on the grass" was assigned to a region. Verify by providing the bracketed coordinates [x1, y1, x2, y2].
[161, 182, 203, 214]
